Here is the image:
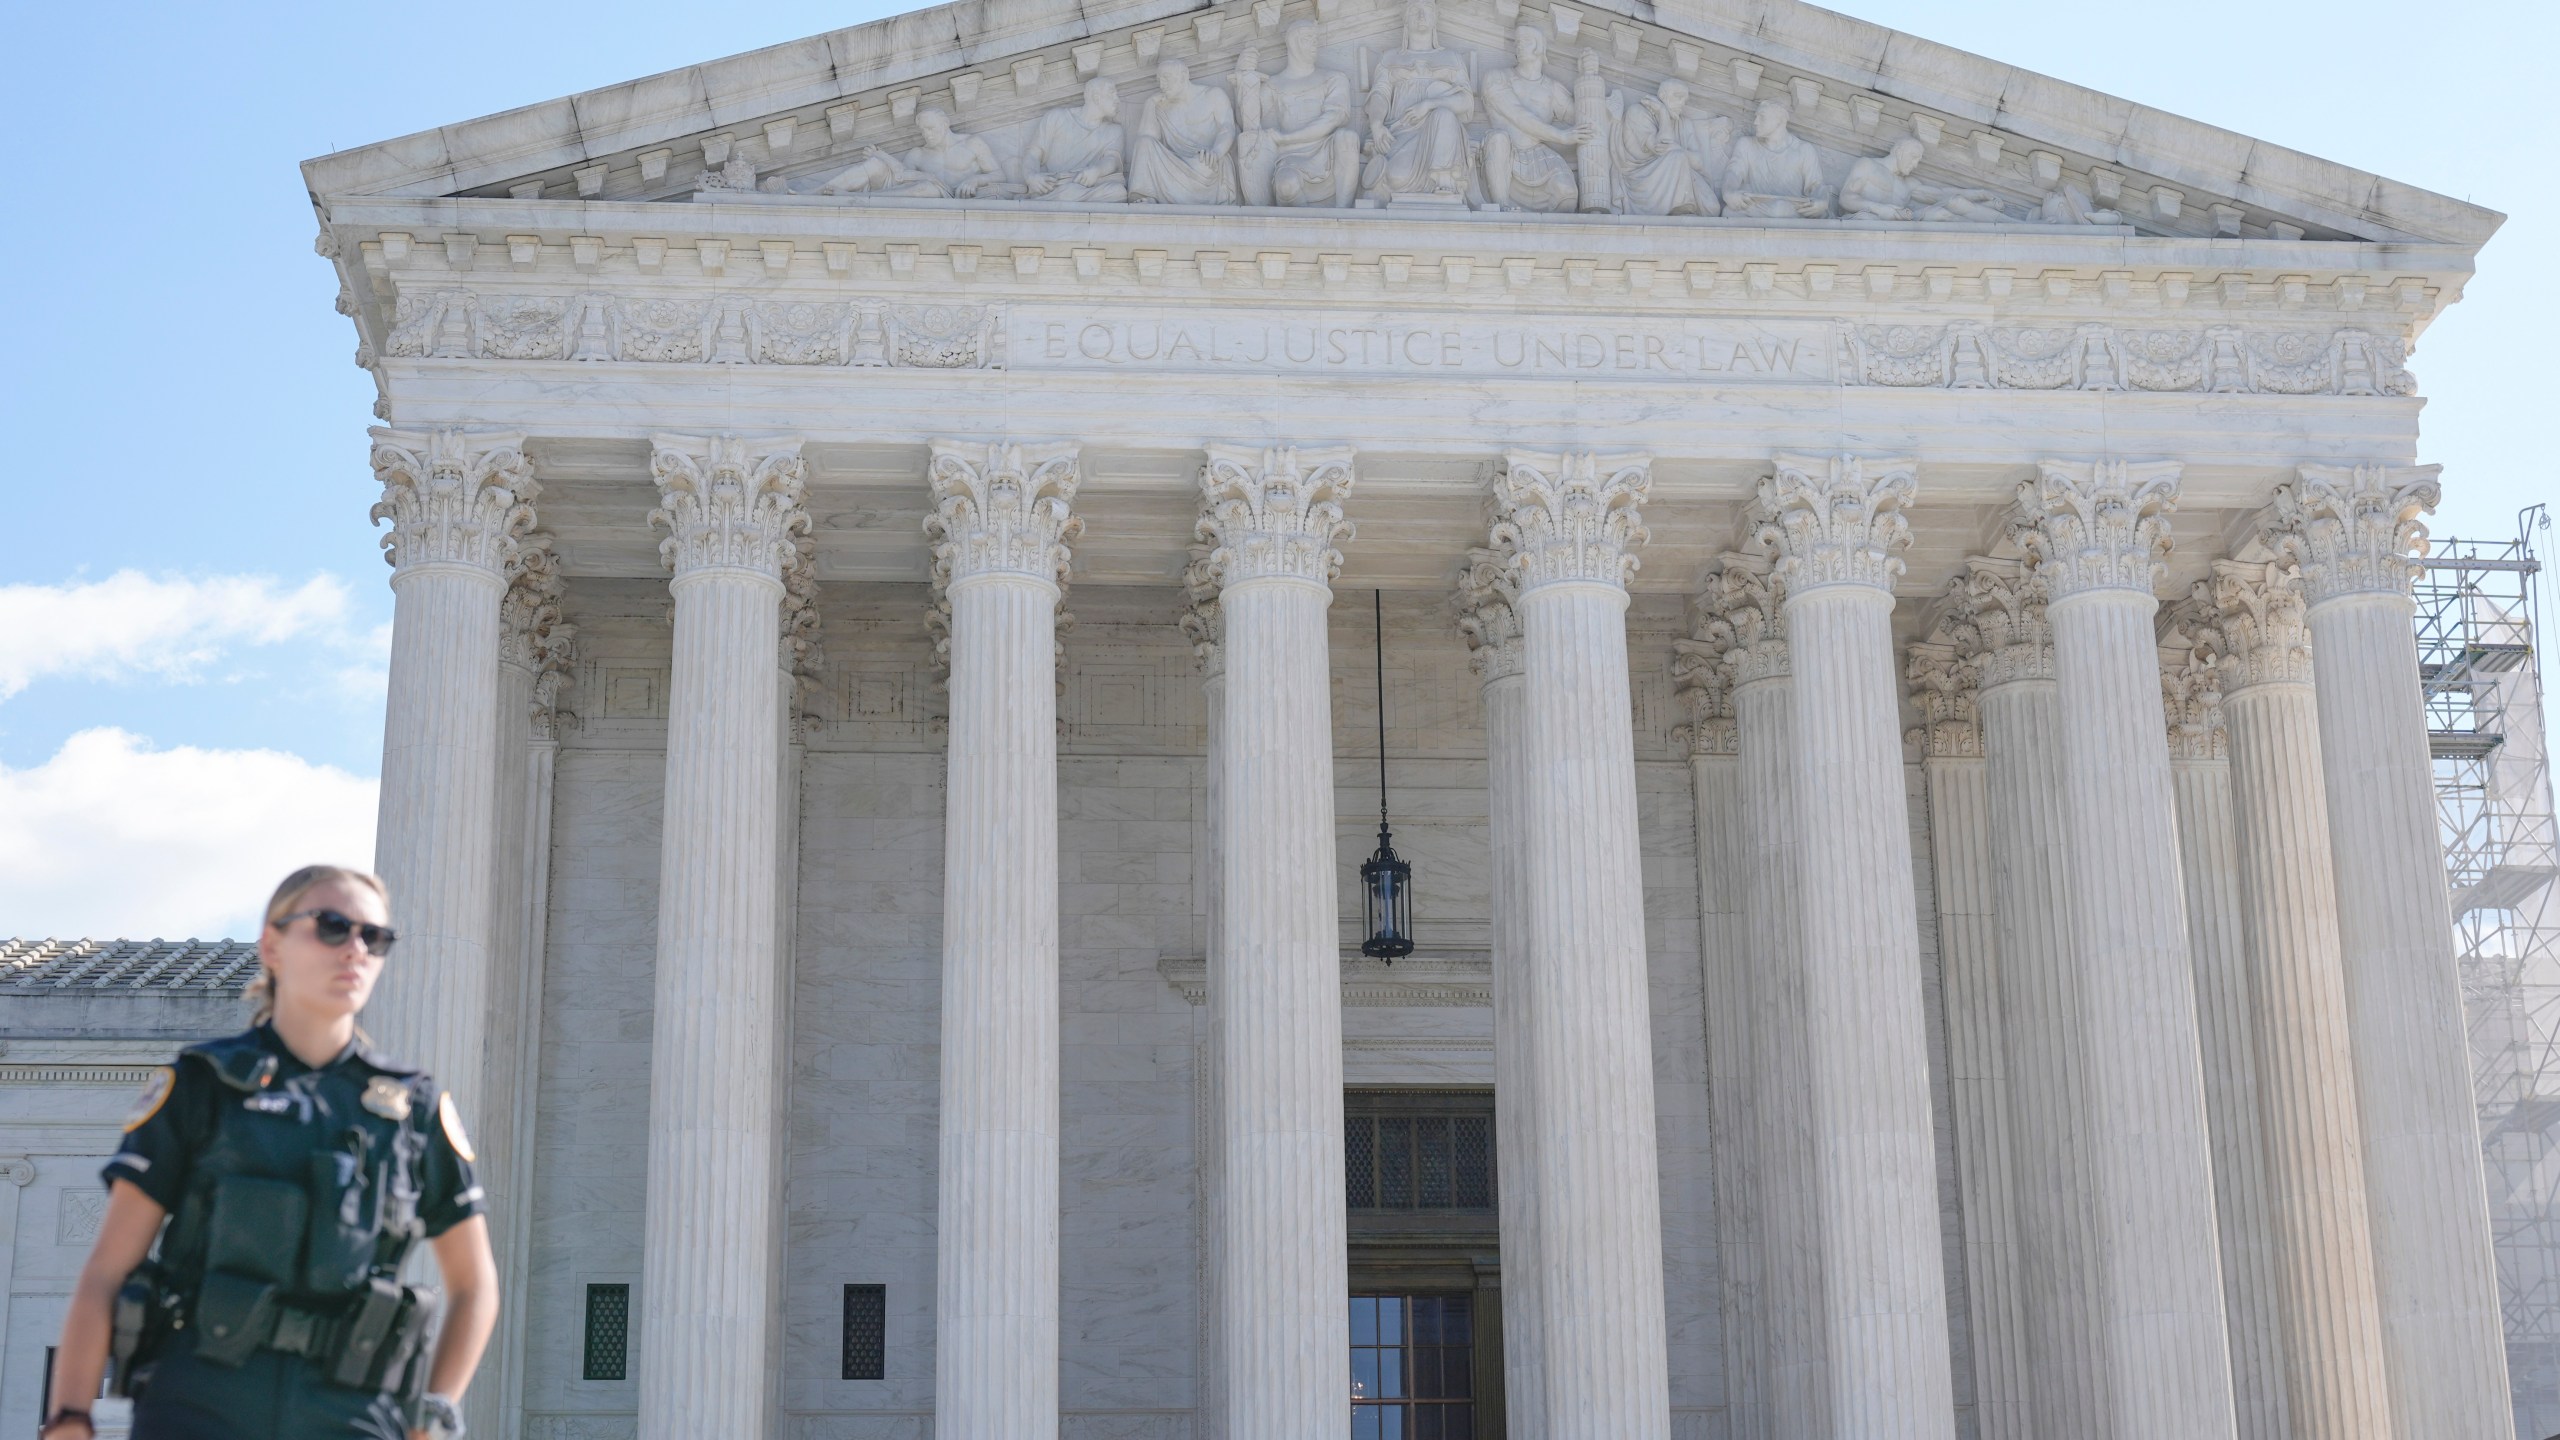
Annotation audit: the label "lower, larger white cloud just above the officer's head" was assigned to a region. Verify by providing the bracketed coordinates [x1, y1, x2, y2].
[0, 730, 379, 938]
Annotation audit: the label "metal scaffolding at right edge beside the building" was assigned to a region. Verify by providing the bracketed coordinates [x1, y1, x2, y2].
[2417, 505, 2560, 1440]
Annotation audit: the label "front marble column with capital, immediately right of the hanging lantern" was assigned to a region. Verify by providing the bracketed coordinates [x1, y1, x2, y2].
[1492, 451, 1672, 1440]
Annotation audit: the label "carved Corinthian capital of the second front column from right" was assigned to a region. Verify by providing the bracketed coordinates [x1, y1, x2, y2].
[2017, 461, 2184, 600]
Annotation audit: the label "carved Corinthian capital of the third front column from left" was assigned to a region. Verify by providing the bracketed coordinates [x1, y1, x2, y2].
[924, 441, 1085, 589]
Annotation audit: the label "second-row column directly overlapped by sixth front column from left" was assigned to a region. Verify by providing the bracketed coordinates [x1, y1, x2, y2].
[1697, 553, 1830, 1440]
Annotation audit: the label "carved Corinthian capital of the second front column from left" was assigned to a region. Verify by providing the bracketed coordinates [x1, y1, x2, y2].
[648, 436, 809, 584]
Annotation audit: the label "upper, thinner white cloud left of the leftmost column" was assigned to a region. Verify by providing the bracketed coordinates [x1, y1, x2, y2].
[0, 569, 376, 700]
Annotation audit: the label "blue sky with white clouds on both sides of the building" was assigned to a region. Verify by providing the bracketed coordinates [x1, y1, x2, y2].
[0, 0, 2560, 935]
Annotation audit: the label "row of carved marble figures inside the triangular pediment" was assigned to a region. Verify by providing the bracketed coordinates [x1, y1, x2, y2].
[696, 0, 2181, 225]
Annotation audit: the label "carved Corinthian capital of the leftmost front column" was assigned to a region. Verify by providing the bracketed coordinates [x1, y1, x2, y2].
[371, 425, 543, 577]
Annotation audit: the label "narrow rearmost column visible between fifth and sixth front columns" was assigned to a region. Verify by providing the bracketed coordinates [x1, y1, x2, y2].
[1672, 602, 1769, 1440]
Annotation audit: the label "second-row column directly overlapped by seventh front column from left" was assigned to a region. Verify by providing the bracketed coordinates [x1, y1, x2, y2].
[1940, 559, 2109, 1437]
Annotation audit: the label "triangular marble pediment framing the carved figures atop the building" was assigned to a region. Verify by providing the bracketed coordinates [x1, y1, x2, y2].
[305, 0, 2501, 251]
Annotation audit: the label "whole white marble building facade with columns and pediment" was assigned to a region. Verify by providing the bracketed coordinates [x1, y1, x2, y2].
[0, 0, 2511, 1440]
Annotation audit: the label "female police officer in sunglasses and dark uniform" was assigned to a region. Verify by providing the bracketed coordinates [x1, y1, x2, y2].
[41, 866, 497, 1440]
